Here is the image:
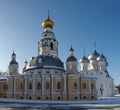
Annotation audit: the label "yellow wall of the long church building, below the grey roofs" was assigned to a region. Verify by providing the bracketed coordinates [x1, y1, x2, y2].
[0, 73, 97, 100]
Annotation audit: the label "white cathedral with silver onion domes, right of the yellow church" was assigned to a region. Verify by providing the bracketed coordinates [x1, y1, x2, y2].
[80, 50, 114, 97]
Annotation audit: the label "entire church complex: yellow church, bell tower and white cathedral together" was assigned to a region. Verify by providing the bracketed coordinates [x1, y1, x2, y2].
[0, 14, 114, 100]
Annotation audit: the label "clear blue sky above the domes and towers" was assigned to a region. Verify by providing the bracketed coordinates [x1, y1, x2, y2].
[0, 0, 120, 84]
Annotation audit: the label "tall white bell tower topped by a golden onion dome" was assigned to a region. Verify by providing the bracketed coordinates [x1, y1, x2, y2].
[38, 12, 58, 56]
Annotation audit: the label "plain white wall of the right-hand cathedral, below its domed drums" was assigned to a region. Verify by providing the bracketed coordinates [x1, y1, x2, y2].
[80, 70, 114, 98]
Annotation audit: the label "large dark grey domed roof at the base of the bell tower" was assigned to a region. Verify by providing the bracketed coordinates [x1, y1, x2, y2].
[24, 55, 65, 71]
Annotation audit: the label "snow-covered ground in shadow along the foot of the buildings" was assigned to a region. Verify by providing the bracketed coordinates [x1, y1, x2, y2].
[0, 96, 120, 109]
